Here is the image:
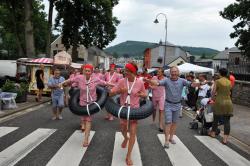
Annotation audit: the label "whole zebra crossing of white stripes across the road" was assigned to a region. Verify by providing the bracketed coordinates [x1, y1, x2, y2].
[0, 127, 250, 166]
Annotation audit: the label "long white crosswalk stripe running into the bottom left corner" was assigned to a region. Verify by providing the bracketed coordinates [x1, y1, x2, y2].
[0, 128, 56, 166]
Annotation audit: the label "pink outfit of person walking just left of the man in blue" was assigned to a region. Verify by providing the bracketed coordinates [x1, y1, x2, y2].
[151, 76, 166, 111]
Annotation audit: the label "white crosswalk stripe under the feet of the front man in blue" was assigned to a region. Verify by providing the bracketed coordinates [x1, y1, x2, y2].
[158, 134, 201, 166]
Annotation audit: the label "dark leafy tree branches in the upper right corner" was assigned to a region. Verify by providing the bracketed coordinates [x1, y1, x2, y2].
[220, 0, 250, 58]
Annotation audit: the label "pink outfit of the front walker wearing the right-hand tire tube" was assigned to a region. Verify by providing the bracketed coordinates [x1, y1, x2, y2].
[111, 78, 146, 123]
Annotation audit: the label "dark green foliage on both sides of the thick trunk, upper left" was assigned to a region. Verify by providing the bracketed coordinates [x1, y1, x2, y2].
[0, 0, 47, 59]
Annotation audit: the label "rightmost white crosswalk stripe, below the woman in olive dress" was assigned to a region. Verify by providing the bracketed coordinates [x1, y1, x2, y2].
[195, 136, 250, 166]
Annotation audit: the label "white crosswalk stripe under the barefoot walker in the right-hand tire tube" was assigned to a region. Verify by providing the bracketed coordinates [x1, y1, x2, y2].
[111, 132, 142, 166]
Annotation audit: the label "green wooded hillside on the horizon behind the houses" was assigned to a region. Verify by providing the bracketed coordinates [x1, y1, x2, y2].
[105, 41, 219, 58]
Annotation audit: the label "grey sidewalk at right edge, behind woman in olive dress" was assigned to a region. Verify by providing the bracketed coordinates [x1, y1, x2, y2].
[185, 104, 250, 147]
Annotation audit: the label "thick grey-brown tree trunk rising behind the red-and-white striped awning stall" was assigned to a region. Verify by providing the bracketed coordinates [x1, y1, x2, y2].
[24, 0, 35, 58]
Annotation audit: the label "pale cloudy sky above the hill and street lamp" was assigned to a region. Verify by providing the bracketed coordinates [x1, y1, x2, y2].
[43, 0, 236, 50]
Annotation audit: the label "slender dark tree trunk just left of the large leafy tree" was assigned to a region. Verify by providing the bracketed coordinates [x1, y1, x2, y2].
[46, 0, 55, 58]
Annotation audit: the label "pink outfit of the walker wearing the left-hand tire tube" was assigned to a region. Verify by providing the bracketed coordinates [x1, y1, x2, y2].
[70, 75, 106, 121]
